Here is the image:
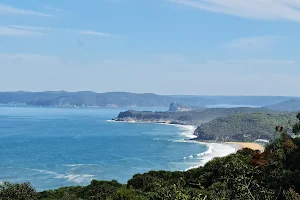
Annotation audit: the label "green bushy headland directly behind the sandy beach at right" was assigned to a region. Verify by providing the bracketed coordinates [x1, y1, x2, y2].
[195, 112, 296, 142]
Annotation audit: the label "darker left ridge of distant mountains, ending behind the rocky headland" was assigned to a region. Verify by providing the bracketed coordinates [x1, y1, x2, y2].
[0, 91, 174, 107]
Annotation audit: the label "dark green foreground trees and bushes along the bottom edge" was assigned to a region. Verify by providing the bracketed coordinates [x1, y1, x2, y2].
[0, 114, 300, 200]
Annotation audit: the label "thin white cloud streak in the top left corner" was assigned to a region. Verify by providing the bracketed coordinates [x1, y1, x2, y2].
[0, 4, 53, 17]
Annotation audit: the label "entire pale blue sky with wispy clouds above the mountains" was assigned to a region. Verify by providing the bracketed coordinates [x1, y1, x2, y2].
[0, 0, 300, 96]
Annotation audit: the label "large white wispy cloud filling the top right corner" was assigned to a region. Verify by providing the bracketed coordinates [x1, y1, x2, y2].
[167, 0, 300, 22]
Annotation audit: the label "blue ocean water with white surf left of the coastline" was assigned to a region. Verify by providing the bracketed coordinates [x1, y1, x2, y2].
[0, 107, 207, 191]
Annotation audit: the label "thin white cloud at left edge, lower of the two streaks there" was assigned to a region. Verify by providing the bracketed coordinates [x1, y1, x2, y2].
[0, 26, 45, 37]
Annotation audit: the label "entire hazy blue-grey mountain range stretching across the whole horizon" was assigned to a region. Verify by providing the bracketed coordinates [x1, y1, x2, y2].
[0, 91, 291, 110]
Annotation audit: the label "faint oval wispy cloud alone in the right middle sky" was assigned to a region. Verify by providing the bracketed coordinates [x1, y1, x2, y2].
[222, 36, 284, 50]
